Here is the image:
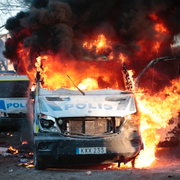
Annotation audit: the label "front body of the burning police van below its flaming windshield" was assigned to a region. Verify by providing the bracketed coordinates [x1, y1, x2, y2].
[33, 64, 143, 169]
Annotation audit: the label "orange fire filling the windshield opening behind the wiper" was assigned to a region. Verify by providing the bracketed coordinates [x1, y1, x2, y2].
[30, 55, 121, 90]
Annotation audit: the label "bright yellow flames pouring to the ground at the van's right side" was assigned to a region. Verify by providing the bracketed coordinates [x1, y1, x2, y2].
[121, 80, 180, 168]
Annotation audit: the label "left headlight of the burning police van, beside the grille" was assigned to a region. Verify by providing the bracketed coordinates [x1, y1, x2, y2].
[39, 114, 58, 132]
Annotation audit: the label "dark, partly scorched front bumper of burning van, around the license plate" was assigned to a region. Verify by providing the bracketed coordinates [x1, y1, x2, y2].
[34, 133, 143, 167]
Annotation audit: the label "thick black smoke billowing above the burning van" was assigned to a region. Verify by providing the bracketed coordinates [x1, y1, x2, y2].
[4, 0, 180, 75]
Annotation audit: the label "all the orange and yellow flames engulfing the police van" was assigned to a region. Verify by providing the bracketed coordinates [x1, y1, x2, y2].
[7, 14, 180, 168]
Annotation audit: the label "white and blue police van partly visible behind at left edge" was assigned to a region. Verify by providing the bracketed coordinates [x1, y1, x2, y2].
[0, 72, 29, 127]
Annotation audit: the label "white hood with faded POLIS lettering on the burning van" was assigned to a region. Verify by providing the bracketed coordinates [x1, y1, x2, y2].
[38, 88, 136, 118]
